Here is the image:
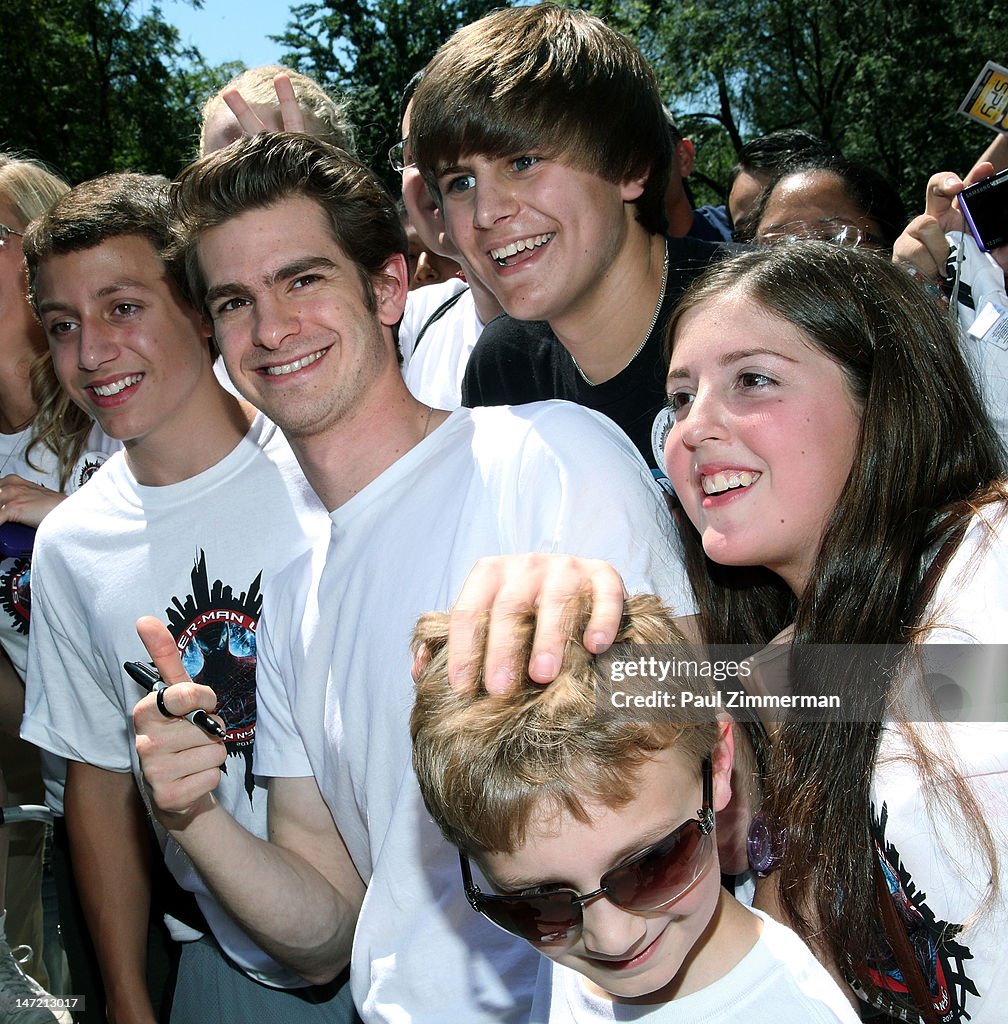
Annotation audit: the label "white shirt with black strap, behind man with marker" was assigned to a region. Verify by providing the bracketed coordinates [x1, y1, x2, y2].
[400, 278, 484, 410]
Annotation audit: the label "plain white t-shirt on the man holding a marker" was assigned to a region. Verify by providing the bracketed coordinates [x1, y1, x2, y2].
[256, 402, 691, 1024]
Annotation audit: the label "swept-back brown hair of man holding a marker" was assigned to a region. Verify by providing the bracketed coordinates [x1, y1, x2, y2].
[172, 132, 409, 312]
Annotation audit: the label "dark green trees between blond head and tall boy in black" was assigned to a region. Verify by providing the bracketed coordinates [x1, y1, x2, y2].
[275, 0, 502, 188]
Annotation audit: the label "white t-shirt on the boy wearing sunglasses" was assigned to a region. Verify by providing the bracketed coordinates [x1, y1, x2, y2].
[529, 910, 859, 1024]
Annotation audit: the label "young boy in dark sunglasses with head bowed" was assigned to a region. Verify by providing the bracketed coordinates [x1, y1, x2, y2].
[411, 595, 858, 1024]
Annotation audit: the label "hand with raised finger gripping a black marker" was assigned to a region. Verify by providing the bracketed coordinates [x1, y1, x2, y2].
[133, 615, 227, 828]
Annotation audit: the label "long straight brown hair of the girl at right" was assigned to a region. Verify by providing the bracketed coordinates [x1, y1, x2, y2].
[669, 242, 1008, 984]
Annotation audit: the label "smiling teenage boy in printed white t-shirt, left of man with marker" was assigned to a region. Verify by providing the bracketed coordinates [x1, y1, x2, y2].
[22, 174, 352, 1024]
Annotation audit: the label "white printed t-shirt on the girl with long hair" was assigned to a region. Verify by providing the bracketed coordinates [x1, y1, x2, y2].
[872, 507, 1008, 1024]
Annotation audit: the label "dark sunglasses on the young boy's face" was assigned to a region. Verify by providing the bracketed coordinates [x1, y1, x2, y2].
[459, 758, 714, 947]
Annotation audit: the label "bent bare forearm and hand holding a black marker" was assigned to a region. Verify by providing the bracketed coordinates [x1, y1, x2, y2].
[133, 617, 365, 984]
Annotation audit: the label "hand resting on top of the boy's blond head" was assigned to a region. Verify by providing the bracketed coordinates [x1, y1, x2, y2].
[448, 554, 626, 693]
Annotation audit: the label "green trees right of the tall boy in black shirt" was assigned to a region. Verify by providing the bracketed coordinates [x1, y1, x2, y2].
[583, 0, 1008, 208]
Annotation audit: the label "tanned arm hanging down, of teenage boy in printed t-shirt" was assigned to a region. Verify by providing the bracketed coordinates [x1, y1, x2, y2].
[64, 761, 157, 1024]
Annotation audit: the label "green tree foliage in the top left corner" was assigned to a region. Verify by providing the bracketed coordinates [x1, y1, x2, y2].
[0, 0, 234, 181]
